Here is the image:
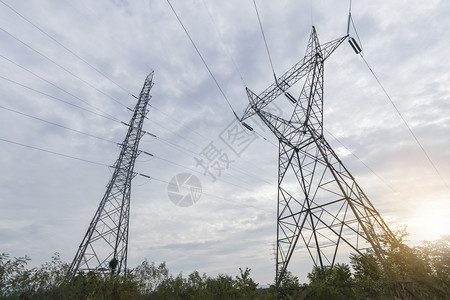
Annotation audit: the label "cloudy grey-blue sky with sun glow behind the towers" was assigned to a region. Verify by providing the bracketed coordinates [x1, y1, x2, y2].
[0, 0, 450, 285]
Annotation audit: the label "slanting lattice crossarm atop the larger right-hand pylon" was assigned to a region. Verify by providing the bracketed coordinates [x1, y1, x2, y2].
[240, 26, 348, 121]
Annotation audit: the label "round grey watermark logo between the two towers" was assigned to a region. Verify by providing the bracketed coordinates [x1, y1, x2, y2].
[167, 173, 202, 207]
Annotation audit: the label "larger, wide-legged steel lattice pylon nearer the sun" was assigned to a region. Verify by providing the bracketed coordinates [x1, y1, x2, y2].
[241, 27, 393, 287]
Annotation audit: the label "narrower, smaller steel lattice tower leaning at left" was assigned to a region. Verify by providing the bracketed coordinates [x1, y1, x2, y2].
[69, 72, 153, 278]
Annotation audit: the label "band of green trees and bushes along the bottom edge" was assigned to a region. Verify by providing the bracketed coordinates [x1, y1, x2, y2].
[0, 230, 450, 300]
